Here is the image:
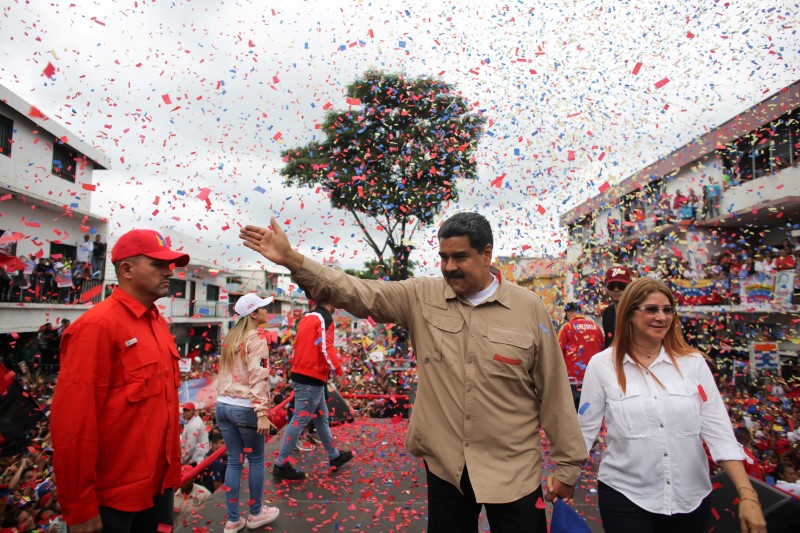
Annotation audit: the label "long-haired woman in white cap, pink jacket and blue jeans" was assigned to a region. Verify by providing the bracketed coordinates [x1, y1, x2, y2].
[216, 293, 280, 533]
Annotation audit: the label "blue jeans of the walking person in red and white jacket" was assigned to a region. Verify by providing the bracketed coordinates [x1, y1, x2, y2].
[275, 381, 339, 465]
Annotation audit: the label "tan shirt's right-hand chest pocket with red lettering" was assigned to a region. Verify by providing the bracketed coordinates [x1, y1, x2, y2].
[483, 327, 533, 378]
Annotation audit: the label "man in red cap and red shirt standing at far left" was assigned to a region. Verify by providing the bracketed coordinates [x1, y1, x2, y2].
[50, 230, 189, 533]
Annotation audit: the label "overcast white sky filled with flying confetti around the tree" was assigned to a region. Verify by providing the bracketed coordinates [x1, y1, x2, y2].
[0, 0, 800, 273]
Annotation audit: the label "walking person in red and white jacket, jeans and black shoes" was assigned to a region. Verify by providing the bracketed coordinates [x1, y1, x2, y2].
[272, 303, 353, 479]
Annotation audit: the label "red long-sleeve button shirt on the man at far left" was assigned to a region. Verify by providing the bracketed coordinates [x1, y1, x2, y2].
[50, 288, 181, 525]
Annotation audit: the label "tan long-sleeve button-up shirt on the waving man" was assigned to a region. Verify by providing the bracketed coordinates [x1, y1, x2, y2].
[293, 257, 587, 503]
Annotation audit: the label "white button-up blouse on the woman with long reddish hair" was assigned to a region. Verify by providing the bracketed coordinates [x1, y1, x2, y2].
[578, 348, 745, 515]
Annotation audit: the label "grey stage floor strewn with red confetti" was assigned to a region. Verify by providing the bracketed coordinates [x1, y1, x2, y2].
[175, 418, 602, 533]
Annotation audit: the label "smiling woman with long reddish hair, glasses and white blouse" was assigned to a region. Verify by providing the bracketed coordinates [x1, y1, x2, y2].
[579, 278, 766, 533]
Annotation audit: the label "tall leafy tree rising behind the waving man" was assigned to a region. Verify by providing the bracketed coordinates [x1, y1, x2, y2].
[281, 71, 485, 280]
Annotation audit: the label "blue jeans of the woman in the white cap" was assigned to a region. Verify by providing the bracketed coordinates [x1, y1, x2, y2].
[217, 402, 264, 522]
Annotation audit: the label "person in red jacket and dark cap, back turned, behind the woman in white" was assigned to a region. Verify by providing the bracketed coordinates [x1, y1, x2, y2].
[558, 302, 605, 408]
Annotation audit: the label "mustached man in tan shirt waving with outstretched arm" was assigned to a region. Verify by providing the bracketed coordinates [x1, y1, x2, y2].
[239, 213, 587, 533]
